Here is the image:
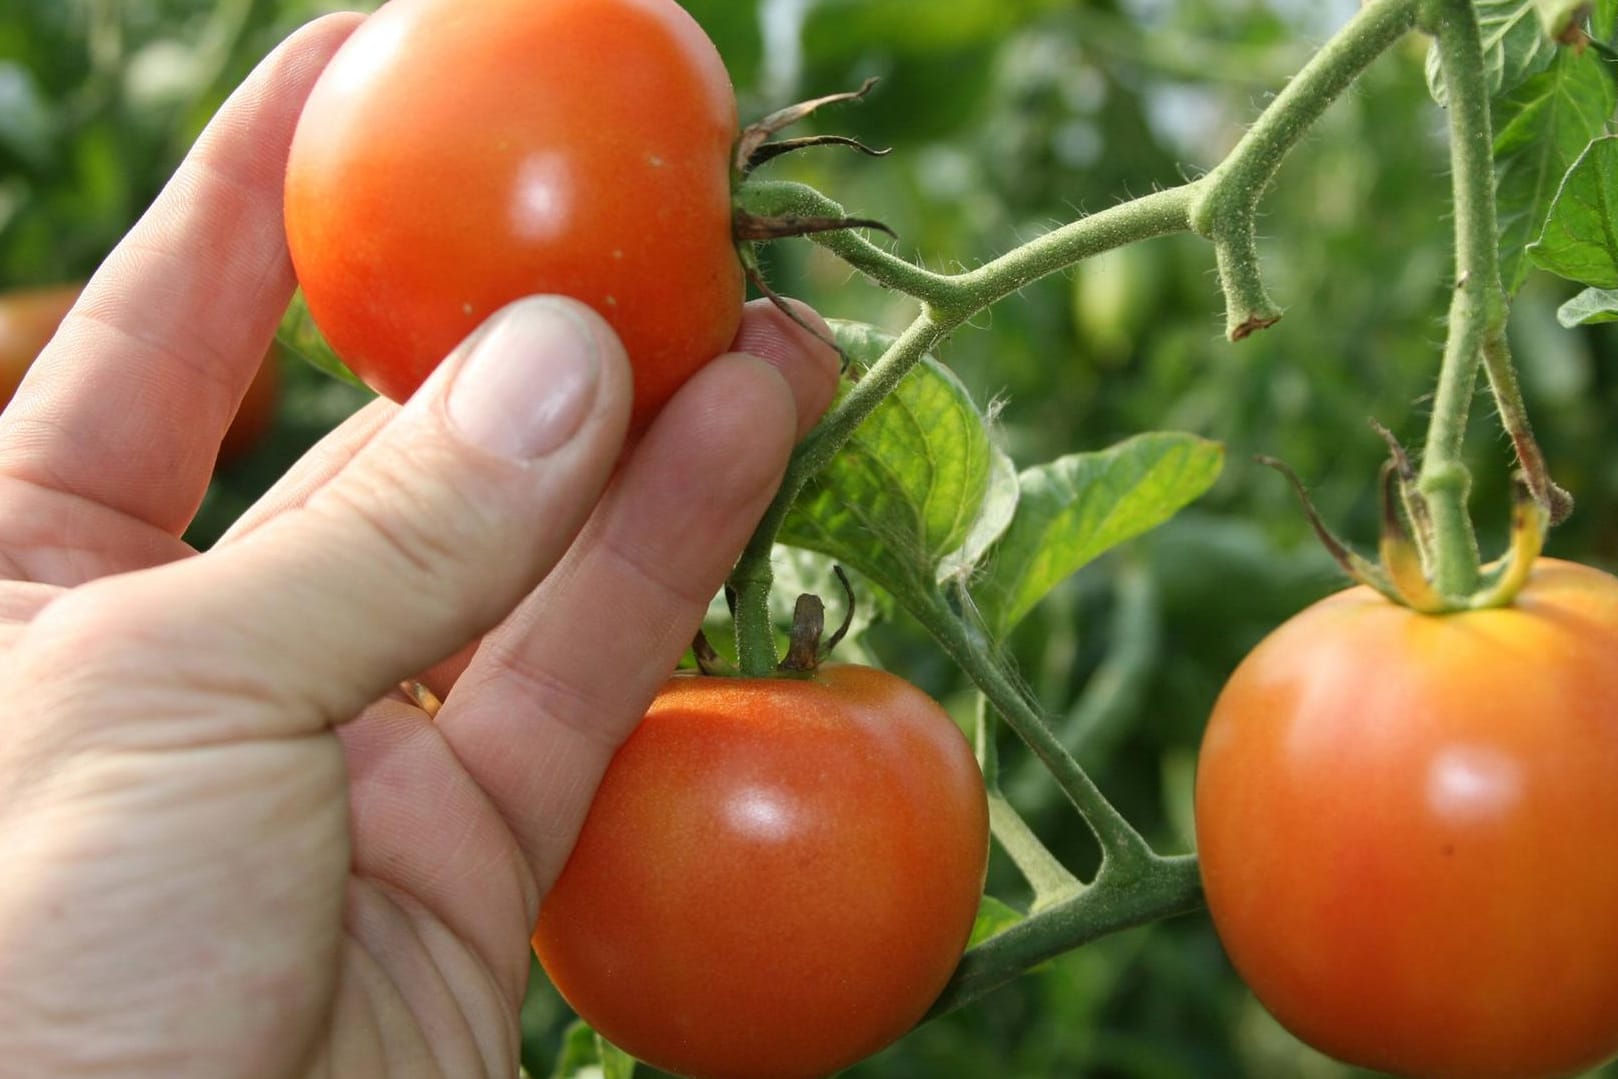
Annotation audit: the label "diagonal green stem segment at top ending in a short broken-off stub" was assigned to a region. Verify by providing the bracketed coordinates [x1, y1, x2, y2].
[1191, 0, 1416, 341]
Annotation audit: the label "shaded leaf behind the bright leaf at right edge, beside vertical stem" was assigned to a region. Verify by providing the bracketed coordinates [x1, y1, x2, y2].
[1495, 50, 1618, 293]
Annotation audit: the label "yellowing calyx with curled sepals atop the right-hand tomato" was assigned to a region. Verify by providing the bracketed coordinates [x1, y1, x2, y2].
[1257, 422, 1550, 615]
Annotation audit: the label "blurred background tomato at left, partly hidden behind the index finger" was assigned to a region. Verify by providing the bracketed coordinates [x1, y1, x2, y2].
[0, 281, 280, 464]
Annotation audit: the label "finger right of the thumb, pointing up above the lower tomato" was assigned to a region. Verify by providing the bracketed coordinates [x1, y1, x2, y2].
[438, 320, 837, 890]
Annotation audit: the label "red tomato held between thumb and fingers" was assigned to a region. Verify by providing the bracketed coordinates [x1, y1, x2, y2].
[286, 0, 743, 429]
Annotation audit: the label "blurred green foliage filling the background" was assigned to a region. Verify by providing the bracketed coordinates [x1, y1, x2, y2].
[12, 0, 1618, 1079]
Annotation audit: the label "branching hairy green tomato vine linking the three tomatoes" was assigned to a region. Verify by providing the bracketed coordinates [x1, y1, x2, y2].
[731, 0, 1598, 1013]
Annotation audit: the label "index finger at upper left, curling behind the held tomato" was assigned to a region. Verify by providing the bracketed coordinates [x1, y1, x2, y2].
[0, 15, 361, 535]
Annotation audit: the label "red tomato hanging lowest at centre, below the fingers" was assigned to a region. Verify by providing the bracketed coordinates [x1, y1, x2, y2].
[534, 665, 989, 1079]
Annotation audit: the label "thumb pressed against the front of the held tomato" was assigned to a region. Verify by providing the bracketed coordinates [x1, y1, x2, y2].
[29, 298, 631, 738]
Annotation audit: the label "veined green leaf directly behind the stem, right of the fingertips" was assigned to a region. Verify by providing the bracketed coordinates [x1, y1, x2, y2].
[780, 322, 995, 597]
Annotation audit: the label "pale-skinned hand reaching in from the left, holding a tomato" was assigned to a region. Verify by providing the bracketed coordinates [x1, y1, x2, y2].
[0, 15, 837, 1079]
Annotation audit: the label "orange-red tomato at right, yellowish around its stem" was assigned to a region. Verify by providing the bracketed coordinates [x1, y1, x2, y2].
[1196, 560, 1618, 1079]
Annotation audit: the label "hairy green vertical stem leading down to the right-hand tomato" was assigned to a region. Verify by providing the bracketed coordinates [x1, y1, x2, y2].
[1417, 0, 1506, 602]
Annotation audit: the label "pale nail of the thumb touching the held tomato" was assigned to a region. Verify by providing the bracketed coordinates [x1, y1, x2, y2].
[448, 298, 600, 461]
